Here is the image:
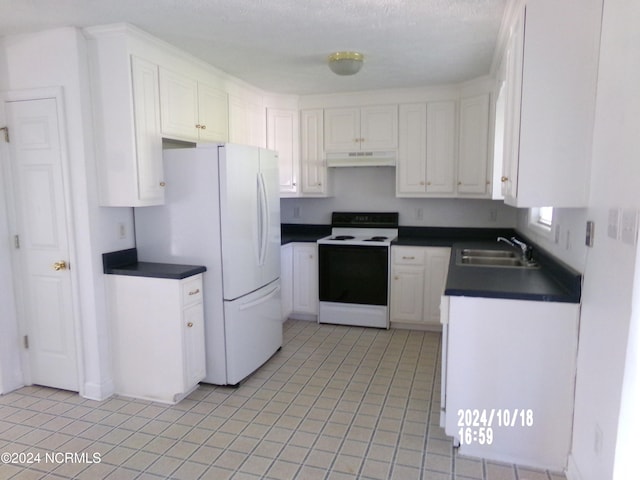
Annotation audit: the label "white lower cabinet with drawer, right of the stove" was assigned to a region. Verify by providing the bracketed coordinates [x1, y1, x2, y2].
[390, 246, 451, 329]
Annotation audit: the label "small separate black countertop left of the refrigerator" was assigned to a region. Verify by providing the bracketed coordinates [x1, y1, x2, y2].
[102, 248, 207, 280]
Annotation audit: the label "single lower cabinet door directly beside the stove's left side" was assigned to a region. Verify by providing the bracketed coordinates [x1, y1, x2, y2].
[293, 243, 318, 315]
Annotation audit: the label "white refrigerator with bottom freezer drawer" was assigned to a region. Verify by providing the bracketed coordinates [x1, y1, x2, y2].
[135, 144, 282, 385]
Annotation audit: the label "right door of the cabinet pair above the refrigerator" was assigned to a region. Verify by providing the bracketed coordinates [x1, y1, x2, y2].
[198, 83, 229, 142]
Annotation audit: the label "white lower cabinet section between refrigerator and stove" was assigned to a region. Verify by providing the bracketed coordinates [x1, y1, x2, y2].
[281, 242, 318, 320]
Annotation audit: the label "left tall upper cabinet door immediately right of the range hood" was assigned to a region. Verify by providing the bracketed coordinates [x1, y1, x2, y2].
[396, 103, 427, 196]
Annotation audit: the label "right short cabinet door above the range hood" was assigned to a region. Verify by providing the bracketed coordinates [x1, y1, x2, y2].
[360, 105, 398, 151]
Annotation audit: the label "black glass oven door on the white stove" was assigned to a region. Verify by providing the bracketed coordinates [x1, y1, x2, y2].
[318, 244, 389, 306]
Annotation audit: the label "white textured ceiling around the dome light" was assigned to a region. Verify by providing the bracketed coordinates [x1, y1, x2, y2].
[0, 0, 507, 94]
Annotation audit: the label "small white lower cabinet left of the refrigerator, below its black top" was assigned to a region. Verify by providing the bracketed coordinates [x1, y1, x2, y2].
[107, 274, 206, 404]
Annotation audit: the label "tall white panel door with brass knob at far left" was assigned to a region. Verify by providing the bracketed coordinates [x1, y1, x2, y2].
[6, 98, 78, 391]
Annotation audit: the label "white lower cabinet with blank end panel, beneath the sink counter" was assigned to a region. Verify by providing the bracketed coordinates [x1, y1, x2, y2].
[440, 296, 580, 471]
